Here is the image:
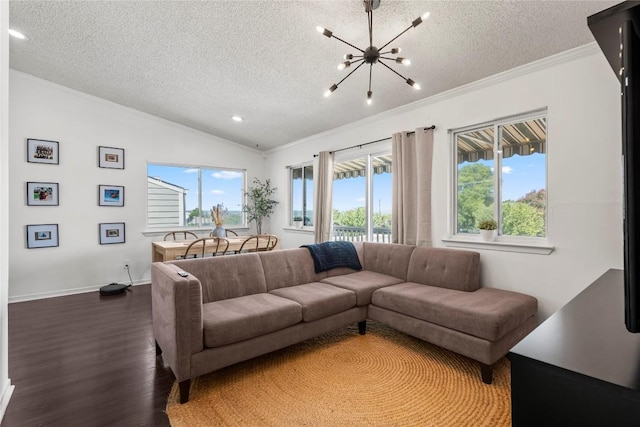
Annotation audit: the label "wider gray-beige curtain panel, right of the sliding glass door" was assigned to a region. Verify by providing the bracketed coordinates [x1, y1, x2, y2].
[391, 128, 433, 246]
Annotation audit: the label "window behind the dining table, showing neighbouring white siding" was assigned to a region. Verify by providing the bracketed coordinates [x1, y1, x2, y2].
[147, 164, 246, 228]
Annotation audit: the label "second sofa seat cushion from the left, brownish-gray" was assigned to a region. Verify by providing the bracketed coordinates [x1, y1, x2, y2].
[270, 282, 356, 322]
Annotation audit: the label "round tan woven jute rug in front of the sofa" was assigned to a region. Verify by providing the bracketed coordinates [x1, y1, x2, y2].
[167, 321, 511, 427]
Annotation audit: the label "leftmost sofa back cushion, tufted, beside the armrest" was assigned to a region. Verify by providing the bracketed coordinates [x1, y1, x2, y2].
[171, 253, 267, 303]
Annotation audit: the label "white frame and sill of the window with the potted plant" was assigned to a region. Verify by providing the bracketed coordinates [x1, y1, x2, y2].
[442, 108, 554, 254]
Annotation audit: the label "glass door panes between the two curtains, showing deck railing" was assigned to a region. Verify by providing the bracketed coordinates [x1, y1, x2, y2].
[333, 153, 392, 243]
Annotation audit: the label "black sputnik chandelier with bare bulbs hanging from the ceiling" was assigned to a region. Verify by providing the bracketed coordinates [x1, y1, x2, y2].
[316, 0, 429, 105]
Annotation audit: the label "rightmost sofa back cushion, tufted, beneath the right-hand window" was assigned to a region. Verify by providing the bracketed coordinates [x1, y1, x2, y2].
[407, 247, 480, 291]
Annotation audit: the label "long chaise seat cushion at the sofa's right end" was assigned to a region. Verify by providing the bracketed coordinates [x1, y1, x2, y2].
[372, 282, 538, 341]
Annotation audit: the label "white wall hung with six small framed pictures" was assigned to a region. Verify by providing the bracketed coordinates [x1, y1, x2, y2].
[9, 70, 264, 301]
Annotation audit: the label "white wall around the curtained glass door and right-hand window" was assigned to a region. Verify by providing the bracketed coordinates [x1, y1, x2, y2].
[266, 44, 624, 322]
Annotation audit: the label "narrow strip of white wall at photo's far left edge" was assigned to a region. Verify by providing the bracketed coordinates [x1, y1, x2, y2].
[0, 2, 14, 422]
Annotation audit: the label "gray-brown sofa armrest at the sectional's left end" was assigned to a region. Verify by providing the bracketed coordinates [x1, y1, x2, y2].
[151, 262, 204, 381]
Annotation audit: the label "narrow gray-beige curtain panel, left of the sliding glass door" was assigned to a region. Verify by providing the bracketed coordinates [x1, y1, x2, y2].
[313, 151, 333, 243]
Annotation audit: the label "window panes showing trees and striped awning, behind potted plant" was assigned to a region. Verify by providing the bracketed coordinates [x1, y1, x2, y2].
[453, 112, 547, 241]
